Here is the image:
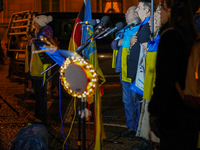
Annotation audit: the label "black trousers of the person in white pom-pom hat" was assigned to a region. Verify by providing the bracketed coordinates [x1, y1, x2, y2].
[32, 79, 47, 126]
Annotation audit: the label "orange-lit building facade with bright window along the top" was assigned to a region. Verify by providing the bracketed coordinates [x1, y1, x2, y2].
[0, 0, 160, 47]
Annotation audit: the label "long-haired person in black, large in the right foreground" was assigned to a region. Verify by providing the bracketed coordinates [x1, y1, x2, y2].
[148, 0, 199, 150]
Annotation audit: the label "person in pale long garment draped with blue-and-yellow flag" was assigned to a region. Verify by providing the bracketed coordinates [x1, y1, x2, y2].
[132, 4, 161, 150]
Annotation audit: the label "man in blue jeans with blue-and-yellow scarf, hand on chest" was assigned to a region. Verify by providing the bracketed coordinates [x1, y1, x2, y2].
[111, 6, 140, 137]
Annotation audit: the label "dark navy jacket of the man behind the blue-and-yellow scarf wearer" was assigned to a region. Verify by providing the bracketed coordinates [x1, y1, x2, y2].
[127, 19, 151, 82]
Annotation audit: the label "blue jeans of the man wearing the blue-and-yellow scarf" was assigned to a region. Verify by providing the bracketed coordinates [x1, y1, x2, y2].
[120, 73, 140, 132]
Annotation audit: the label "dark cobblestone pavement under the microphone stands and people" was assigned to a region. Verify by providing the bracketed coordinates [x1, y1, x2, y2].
[0, 65, 138, 150]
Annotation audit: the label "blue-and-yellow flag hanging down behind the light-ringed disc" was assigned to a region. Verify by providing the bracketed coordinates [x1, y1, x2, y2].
[82, 0, 105, 150]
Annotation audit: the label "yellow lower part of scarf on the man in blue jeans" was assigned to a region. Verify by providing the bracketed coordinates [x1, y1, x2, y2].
[121, 48, 131, 83]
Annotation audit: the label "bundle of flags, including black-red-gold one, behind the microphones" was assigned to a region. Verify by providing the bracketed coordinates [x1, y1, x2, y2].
[68, 0, 105, 150]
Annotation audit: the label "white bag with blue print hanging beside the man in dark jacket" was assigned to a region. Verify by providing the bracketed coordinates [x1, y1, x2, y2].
[135, 44, 146, 91]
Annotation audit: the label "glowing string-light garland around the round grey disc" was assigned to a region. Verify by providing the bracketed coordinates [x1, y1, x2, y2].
[60, 56, 98, 98]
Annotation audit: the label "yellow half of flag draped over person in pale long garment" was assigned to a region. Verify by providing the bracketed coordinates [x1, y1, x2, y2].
[143, 52, 157, 100]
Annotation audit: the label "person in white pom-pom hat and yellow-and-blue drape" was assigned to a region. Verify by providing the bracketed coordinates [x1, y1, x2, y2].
[26, 15, 54, 126]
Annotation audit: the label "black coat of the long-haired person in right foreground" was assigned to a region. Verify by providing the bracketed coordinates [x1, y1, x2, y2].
[148, 23, 198, 134]
